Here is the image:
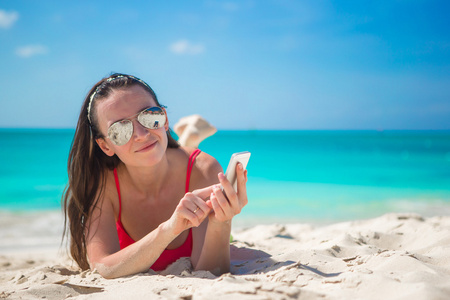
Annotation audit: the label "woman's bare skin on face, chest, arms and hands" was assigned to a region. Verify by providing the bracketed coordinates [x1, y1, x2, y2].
[82, 86, 247, 278]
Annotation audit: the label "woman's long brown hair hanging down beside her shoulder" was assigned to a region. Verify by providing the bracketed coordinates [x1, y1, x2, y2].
[62, 73, 179, 270]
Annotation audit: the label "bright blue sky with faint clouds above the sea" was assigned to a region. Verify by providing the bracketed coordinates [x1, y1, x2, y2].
[0, 0, 450, 130]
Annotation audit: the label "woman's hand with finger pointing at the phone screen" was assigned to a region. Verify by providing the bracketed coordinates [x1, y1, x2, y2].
[167, 186, 214, 235]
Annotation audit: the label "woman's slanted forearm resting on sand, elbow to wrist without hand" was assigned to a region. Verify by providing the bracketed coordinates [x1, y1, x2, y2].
[91, 223, 176, 279]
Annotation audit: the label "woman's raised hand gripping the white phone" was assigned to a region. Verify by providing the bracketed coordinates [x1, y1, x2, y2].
[206, 163, 248, 222]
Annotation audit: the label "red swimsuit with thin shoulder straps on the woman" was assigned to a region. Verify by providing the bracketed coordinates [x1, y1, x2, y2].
[114, 149, 201, 271]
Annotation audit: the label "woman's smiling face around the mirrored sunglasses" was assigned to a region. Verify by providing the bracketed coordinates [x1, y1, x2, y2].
[96, 85, 169, 166]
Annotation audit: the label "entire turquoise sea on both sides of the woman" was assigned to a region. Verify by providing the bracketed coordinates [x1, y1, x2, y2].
[0, 129, 450, 251]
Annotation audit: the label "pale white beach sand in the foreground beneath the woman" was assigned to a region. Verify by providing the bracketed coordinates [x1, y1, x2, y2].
[0, 214, 450, 300]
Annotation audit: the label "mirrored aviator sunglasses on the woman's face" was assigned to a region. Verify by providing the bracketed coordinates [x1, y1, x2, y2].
[108, 106, 166, 146]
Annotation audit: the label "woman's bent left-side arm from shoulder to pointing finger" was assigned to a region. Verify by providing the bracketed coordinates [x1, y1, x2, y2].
[86, 187, 212, 278]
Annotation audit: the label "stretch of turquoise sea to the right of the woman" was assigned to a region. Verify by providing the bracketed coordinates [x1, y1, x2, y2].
[201, 131, 450, 223]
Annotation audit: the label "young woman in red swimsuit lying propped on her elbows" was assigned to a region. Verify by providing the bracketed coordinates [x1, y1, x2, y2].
[63, 74, 247, 278]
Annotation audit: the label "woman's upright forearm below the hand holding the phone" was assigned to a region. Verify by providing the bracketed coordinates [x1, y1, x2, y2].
[194, 220, 231, 275]
